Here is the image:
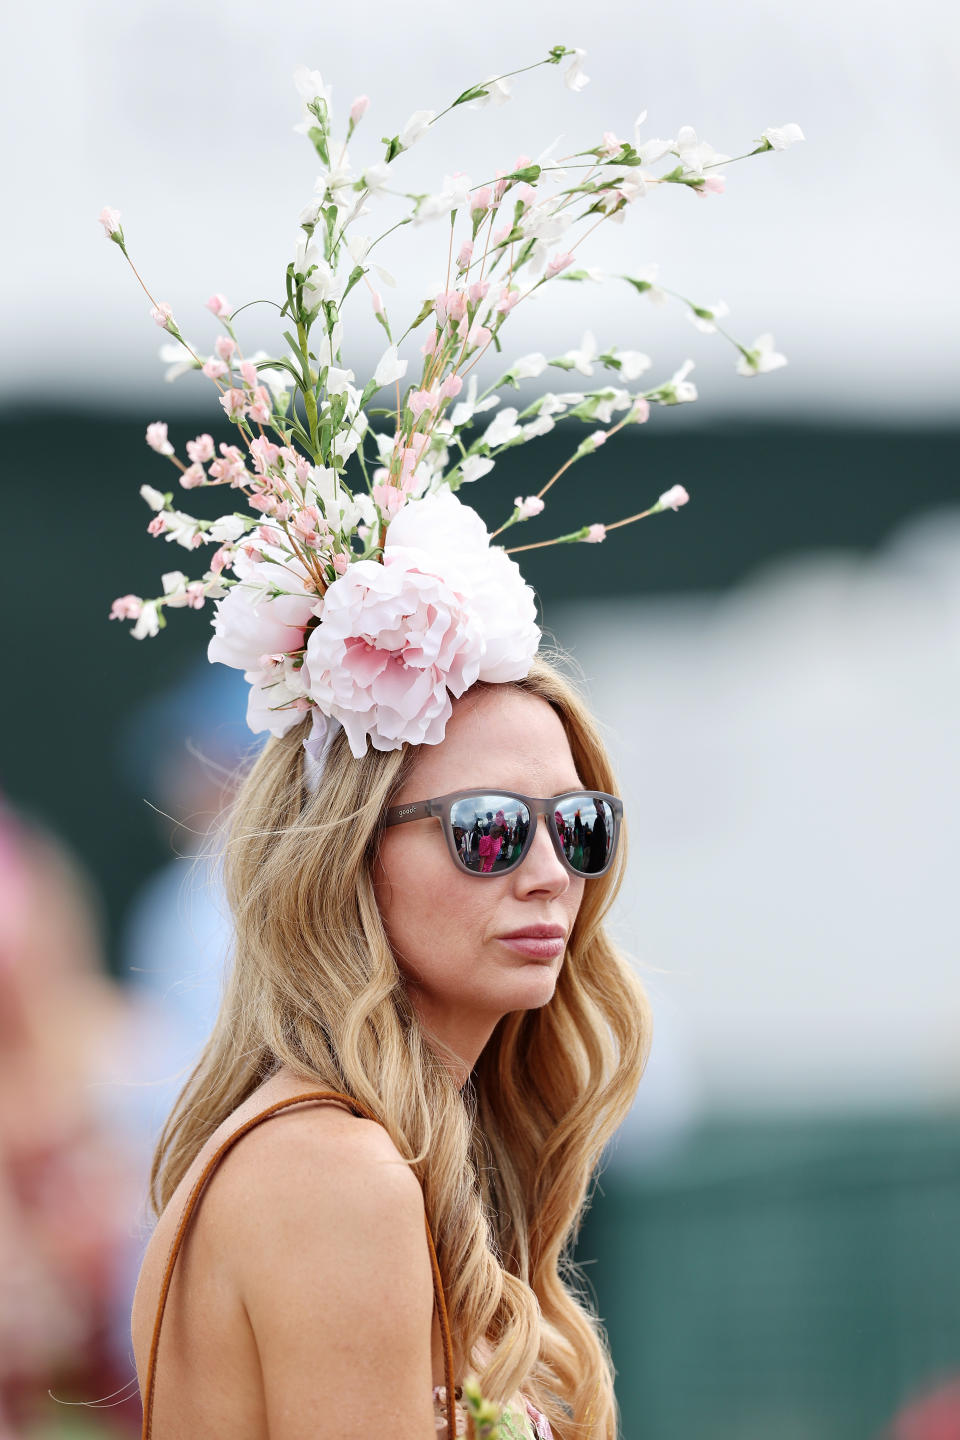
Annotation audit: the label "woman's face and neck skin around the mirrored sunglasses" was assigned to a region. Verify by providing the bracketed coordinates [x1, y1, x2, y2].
[374, 684, 584, 1079]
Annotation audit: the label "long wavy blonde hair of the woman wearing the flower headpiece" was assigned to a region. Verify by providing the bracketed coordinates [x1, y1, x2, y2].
[150, 657, 652, 1440]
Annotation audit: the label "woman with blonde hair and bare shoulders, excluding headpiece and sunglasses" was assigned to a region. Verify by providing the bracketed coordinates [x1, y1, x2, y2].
[132, 658, 651, 1440]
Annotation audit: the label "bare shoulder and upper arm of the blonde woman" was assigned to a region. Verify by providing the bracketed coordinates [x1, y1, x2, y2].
[207, 1104, 435, 1440]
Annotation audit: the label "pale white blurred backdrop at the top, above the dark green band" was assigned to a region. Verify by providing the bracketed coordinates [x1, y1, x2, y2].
[0, 0, 960, 422]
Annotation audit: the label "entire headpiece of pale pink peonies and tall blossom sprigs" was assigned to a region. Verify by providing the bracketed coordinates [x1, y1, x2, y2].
[99, 46, 803, 783]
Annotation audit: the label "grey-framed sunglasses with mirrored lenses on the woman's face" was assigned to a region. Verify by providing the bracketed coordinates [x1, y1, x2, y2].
[386, 791, 623, 880]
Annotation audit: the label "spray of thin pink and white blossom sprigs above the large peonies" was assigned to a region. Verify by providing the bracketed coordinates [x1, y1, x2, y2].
[99, 46, 803, 659]
